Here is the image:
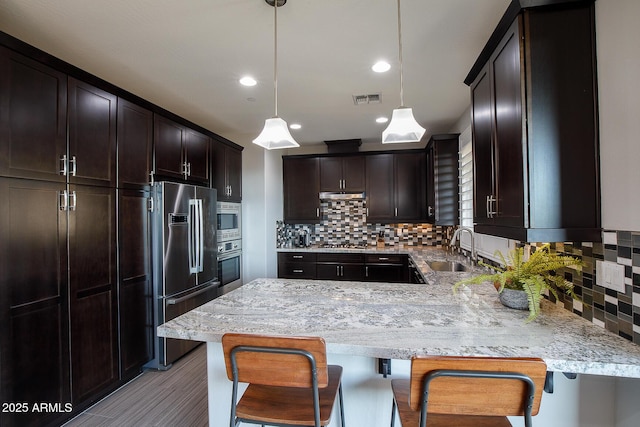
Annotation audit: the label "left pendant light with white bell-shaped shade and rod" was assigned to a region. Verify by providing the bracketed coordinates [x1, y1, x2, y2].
[253, 0, 300, 150]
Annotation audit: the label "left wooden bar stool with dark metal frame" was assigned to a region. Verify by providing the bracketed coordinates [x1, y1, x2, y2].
[222, 333, 344, 427]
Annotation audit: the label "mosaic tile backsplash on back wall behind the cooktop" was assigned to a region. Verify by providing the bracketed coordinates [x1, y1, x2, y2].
[276, 200, 451, 248]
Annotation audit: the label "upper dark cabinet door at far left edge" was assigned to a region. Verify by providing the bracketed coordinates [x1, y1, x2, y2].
[0, 46, 67, 182]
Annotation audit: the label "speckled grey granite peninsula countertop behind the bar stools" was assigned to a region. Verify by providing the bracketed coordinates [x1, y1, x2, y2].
[158, 273, 640, 378]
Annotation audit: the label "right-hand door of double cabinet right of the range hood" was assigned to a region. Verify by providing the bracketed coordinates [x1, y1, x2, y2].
[394, 152, 426, 221]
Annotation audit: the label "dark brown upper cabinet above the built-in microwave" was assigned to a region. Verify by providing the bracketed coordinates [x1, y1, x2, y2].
[212, 140, 242, 202]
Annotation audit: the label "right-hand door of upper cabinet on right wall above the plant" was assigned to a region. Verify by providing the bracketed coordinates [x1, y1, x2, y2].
[491, 20, 524, 226]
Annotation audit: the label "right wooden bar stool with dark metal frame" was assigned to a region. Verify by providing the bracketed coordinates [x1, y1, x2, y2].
[391, 356, 547, 427]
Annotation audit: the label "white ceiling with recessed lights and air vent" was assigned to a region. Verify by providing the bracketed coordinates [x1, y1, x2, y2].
[0, 0, 510, 145]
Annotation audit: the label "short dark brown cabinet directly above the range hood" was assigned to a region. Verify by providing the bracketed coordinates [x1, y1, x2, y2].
[320, 155, 366, 192]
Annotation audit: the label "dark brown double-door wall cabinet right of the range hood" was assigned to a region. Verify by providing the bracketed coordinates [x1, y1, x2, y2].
[366, 150, 426, 223]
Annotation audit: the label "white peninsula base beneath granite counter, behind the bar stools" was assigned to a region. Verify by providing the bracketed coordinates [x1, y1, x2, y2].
[207, 342, 640, 427]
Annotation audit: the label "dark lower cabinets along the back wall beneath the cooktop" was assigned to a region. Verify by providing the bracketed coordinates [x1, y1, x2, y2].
[278, 252, 410, 283]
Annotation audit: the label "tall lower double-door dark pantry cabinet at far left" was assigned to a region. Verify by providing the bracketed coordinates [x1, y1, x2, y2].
[0, 178, 126, 426]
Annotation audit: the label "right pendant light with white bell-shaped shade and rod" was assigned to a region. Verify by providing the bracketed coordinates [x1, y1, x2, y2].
[382, 0, 425, 144]
